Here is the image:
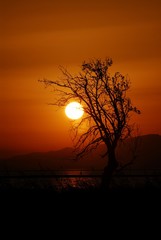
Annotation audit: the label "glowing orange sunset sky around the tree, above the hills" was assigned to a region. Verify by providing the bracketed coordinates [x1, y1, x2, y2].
[0, 0, 161, 154]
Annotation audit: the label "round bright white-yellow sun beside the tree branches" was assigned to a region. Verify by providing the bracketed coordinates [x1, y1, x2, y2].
[65, 102, 84, 120]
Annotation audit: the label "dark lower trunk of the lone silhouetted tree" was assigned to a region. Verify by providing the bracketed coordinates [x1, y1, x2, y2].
[101, 149, 118, 191]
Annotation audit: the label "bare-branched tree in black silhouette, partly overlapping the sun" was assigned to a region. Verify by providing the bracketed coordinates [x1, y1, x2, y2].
[40, 58, 140, 189]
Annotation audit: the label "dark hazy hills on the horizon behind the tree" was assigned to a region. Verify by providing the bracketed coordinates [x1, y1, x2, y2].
[0, 134, 161, 171]
